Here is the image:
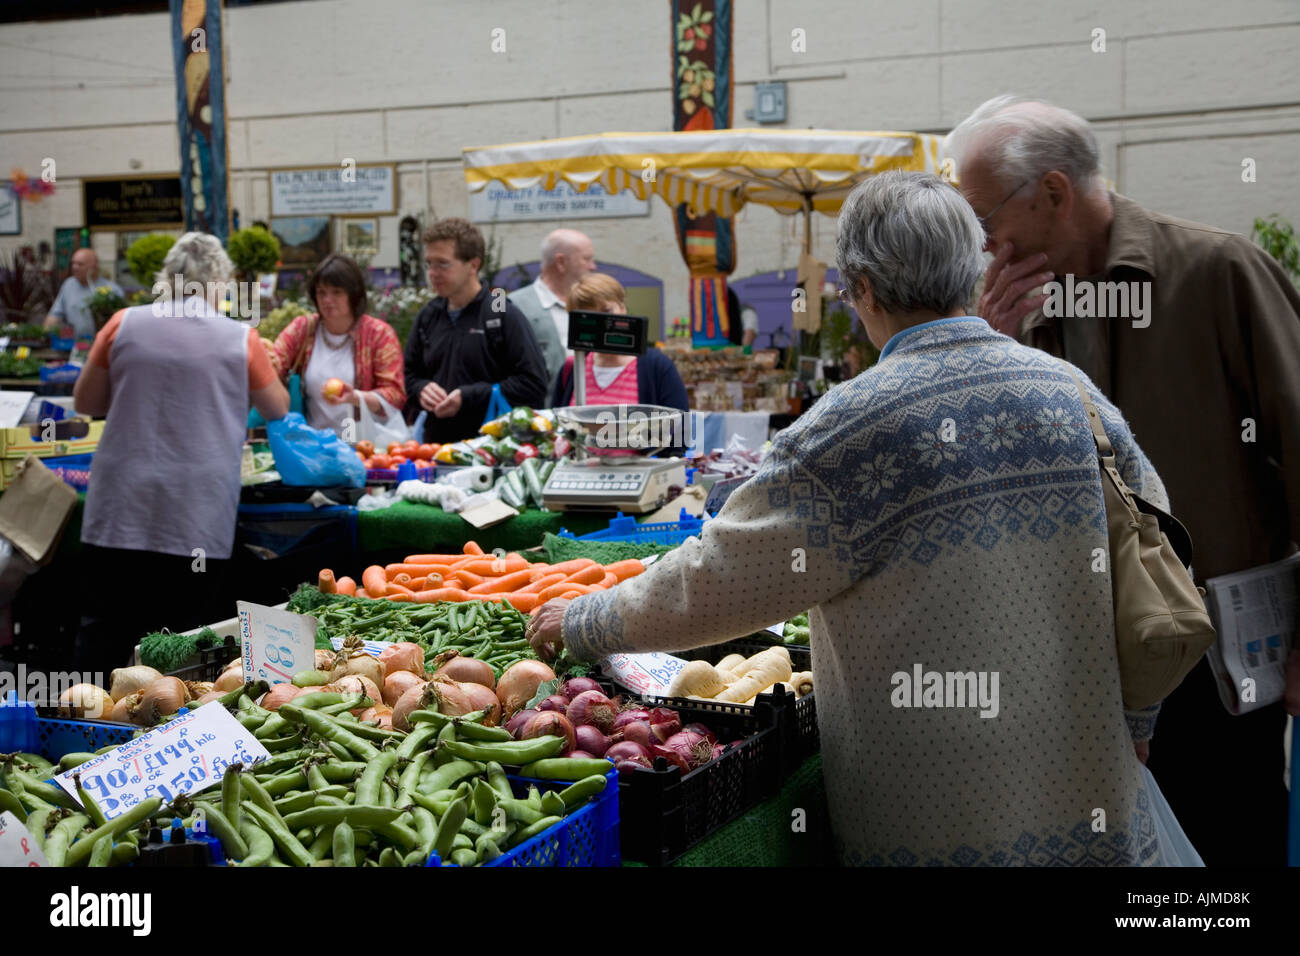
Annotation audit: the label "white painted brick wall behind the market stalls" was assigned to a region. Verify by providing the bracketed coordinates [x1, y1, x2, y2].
[0, 0, 1300, 316]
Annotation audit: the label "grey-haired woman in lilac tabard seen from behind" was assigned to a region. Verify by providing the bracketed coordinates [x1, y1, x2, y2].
[73, 233, 289, 674]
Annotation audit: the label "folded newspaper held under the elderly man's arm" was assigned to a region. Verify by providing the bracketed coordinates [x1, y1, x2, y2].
[1205, 553, 1300, 714]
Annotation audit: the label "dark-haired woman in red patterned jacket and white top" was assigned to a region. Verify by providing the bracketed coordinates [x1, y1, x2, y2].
[270, 254, 406, 434]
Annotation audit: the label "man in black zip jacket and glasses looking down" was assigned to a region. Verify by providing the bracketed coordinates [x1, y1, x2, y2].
[406, 219, 546, 444]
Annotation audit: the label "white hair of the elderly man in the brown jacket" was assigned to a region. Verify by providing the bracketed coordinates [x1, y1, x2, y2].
[944, 95, 1102, 193]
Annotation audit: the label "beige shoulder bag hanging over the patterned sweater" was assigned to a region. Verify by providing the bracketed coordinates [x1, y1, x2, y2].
[1066, 369, 1217, 709]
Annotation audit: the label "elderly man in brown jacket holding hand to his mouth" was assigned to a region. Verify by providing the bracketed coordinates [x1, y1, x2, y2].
[948, 96, 1300, 866]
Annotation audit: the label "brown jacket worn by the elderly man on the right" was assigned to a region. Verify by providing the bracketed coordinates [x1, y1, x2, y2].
[1021, 194, 1300, 580]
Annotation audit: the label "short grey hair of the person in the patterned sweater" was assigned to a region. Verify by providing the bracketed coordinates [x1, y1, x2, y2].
[835, 172, 984, 315]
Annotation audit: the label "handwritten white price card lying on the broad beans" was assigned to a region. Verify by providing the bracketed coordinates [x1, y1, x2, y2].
[55, 704, 270, 819]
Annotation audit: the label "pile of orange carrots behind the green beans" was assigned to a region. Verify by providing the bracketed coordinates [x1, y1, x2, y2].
[317, 541, 645, 614]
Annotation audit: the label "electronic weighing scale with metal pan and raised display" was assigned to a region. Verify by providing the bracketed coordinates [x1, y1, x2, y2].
[542, 311, 689, 514]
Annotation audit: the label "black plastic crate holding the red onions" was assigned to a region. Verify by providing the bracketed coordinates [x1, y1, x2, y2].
[602, 682, 785, 866]
